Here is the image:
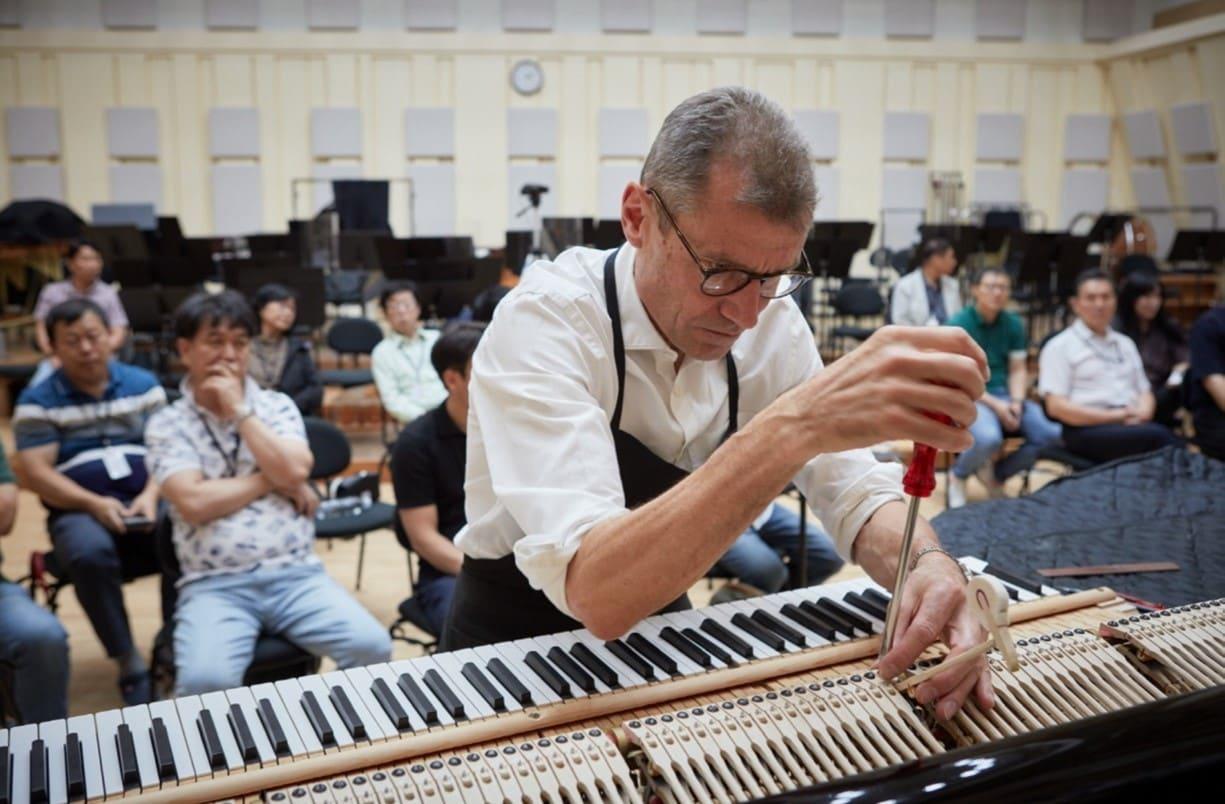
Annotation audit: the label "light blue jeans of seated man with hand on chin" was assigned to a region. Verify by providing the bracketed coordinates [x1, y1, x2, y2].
[174, 564, 391, 695]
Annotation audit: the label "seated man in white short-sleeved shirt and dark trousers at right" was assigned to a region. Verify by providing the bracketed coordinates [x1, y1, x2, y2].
[1038, 268, 1178, 462]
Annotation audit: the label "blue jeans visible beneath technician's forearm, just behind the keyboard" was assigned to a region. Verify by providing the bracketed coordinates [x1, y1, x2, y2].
[718, 504, 843, 593]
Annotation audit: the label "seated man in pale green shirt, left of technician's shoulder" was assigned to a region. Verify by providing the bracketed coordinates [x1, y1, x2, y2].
[370, 282, 447, 424]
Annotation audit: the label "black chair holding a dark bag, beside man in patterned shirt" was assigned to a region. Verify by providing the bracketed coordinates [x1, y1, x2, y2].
[304, 415, 396, 590]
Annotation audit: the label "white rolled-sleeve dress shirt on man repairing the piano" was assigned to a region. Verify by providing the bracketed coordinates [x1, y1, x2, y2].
[456, 244, 902, 615]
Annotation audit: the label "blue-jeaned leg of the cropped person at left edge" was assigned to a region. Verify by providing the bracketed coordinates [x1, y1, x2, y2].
[0, 581, 69, 723]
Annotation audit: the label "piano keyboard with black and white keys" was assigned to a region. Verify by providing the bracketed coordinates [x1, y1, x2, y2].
[0, 559, 1057, 804]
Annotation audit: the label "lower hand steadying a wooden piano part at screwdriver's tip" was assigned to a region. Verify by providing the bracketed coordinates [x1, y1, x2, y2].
[878, 554, 995, 721]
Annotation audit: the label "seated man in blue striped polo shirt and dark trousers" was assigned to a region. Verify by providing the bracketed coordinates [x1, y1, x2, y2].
[12, 299, 165, 705]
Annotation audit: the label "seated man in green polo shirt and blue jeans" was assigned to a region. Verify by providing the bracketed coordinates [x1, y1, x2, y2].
[948, 268, 1060, 509]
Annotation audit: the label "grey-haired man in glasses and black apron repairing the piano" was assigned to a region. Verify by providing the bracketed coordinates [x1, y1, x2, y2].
[443, 87, 991, 717]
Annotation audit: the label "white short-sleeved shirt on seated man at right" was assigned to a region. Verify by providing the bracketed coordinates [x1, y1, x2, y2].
[1038, 319, 1150, 408]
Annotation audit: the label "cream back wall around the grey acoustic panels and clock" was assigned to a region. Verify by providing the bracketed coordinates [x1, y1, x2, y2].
[0, 18, 1225, 245]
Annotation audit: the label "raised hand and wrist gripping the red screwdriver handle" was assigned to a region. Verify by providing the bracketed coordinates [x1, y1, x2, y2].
[771, 326, 987, 455]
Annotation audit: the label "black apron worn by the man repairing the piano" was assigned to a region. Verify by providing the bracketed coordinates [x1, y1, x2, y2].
[441, 250, 740, 651]
